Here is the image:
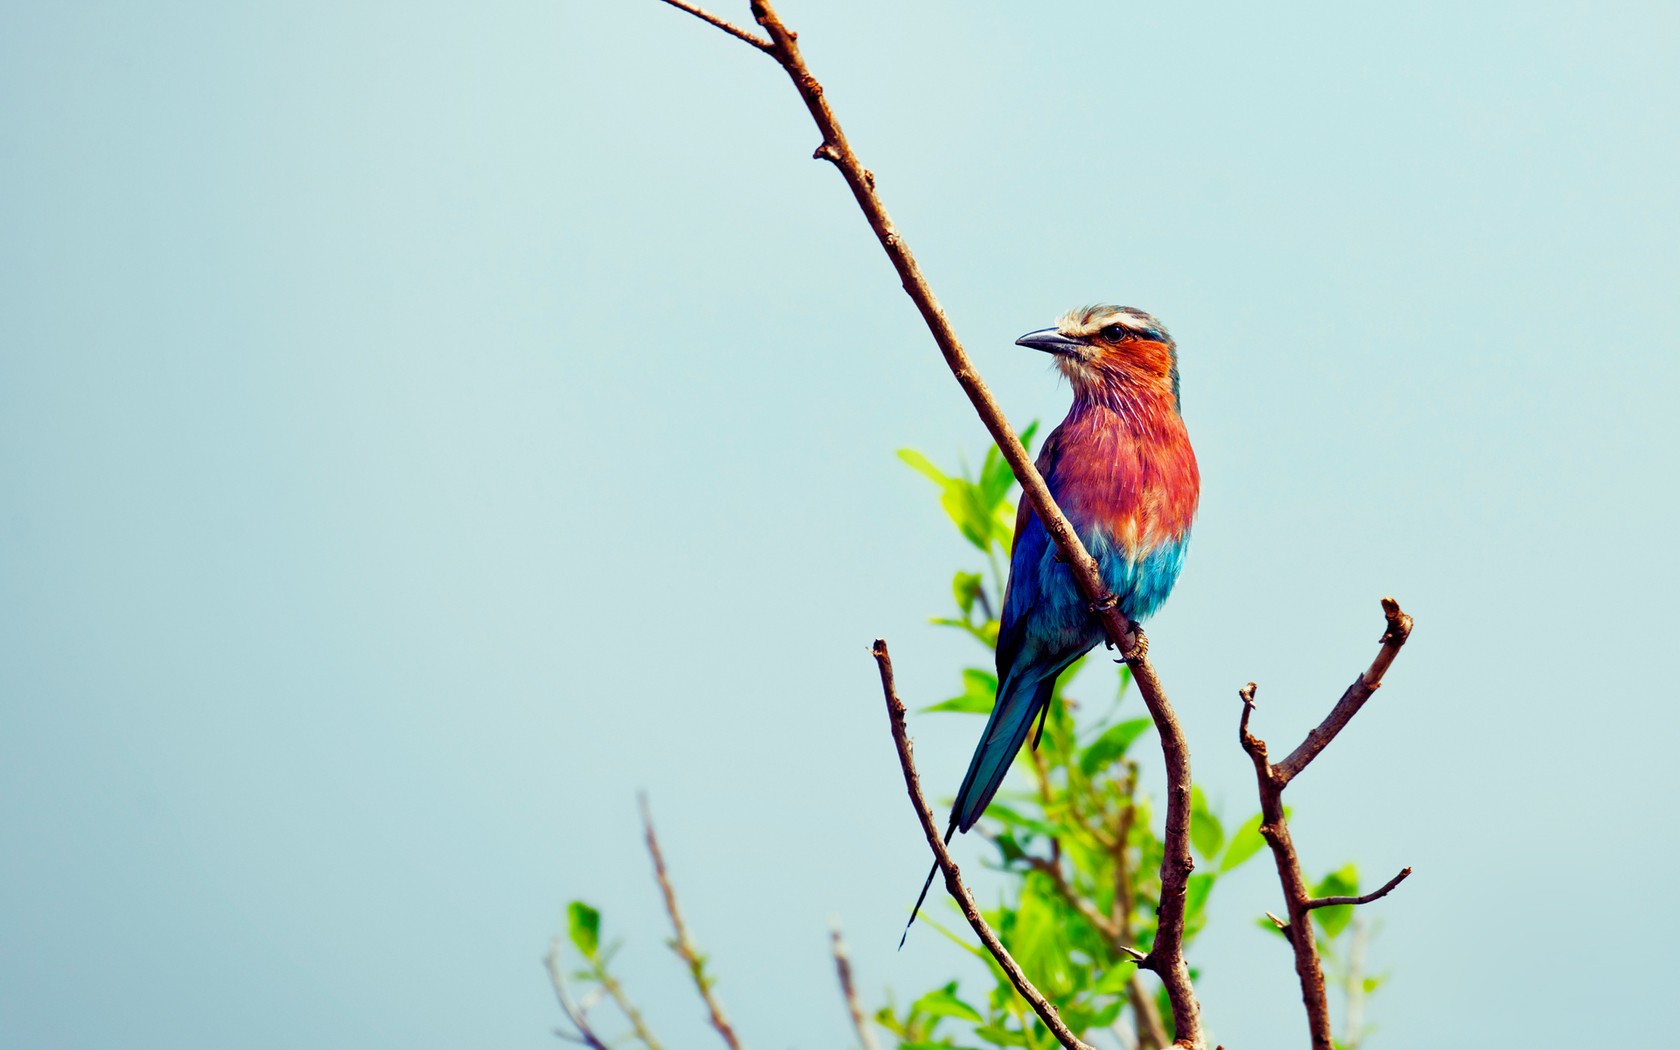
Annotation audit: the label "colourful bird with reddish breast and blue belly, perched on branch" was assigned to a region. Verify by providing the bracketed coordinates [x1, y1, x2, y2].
[899, 306, 1201, 948]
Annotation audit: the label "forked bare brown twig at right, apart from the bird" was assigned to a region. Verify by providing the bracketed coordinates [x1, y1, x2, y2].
[1236, 598, 1411, 1050]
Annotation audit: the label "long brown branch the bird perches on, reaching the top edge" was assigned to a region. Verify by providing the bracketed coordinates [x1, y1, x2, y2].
[665, 0, 1205, 1050]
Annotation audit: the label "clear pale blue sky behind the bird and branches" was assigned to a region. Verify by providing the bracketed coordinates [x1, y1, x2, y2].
[0, 0, 1680, 1050]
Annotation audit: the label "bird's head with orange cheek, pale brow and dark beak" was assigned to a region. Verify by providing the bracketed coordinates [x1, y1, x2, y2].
[1015, 306, 1178, 408]
